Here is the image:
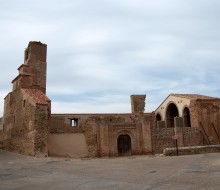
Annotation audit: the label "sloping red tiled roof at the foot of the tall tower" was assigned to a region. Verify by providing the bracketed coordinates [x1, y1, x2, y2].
[22, 88, 50, 105]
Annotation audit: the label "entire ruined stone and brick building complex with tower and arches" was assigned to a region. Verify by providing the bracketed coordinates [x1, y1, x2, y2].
[2, 42, 220, 157]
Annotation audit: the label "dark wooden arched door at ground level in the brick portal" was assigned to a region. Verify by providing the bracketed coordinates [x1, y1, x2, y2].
[117, 135, 131, 156]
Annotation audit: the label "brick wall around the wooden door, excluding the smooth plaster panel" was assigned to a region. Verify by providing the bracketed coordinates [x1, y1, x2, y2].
[50, 114, 152, 157]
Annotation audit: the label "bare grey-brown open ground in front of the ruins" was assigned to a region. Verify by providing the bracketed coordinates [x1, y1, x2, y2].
[0, 150, 220, 190]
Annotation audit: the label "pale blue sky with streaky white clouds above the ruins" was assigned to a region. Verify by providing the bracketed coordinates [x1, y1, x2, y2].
[0, 0, 220, 116]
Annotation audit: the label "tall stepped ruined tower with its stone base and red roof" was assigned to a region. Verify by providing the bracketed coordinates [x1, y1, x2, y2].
[3, 42, 50, 156]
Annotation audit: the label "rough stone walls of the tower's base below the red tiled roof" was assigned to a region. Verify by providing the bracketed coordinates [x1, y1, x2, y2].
[3, 90, 50, 156]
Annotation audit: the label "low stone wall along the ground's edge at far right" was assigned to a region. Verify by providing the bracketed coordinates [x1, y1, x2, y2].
[163, 145, 220, 156]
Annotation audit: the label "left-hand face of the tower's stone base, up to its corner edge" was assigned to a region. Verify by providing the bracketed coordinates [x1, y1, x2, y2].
[3, 90, 35, 155]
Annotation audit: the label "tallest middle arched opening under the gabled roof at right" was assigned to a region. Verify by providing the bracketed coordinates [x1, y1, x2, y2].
[166, 103, 179, 127]
